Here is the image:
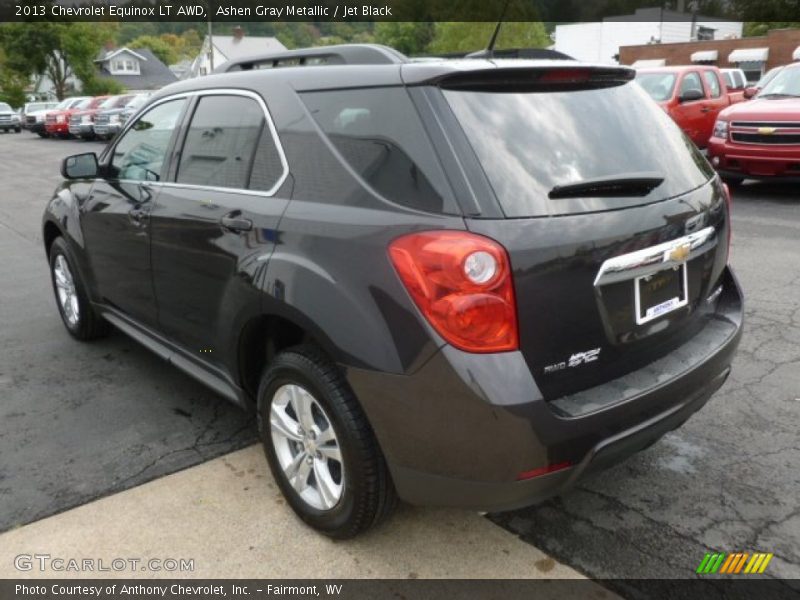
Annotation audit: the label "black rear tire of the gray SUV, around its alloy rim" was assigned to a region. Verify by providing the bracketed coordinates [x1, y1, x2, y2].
[258, 344, 397, 539]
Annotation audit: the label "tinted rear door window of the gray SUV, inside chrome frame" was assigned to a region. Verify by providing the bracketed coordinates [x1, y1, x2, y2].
[177, 96, 283, 191]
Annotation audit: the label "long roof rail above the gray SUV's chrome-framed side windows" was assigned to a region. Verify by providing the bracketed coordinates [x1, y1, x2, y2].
[214, 44, 408, 73]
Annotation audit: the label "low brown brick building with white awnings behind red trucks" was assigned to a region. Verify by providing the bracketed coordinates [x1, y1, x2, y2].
[619, 29, 800, 82]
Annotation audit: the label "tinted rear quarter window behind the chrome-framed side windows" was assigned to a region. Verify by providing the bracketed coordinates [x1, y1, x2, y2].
[303, 88, 454, 212]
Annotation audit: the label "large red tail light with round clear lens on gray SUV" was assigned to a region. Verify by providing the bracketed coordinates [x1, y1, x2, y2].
[389, 231, 519, 353]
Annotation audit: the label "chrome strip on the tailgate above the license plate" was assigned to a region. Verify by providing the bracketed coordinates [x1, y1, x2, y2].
[594, 227, 717, 287]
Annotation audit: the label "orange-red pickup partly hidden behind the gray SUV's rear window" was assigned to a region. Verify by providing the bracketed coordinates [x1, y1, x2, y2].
[636, 65, 743, 148]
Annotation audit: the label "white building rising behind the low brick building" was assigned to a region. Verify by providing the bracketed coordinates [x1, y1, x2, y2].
[554, 8, 743, 64]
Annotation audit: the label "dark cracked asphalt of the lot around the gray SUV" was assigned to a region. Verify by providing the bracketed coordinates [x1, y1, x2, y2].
[0, 132, 800, 578]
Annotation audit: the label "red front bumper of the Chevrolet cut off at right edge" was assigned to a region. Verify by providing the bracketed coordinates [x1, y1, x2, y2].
[708, 138, 800, 179]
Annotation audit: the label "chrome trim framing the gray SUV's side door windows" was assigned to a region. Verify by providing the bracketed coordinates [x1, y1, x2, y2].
[103, 88, 289, 197]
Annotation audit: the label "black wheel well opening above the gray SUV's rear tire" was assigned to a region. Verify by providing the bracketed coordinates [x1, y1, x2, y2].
[239, 316, 312, 398]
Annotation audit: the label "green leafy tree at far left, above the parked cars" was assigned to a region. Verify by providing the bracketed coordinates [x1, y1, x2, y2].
[0, 22, 113, 99]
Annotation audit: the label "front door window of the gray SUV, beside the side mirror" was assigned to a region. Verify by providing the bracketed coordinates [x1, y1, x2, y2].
[111, 99, 186, 181]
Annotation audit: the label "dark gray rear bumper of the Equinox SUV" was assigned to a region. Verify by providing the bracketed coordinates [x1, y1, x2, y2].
[348, 269, 743, 510]
